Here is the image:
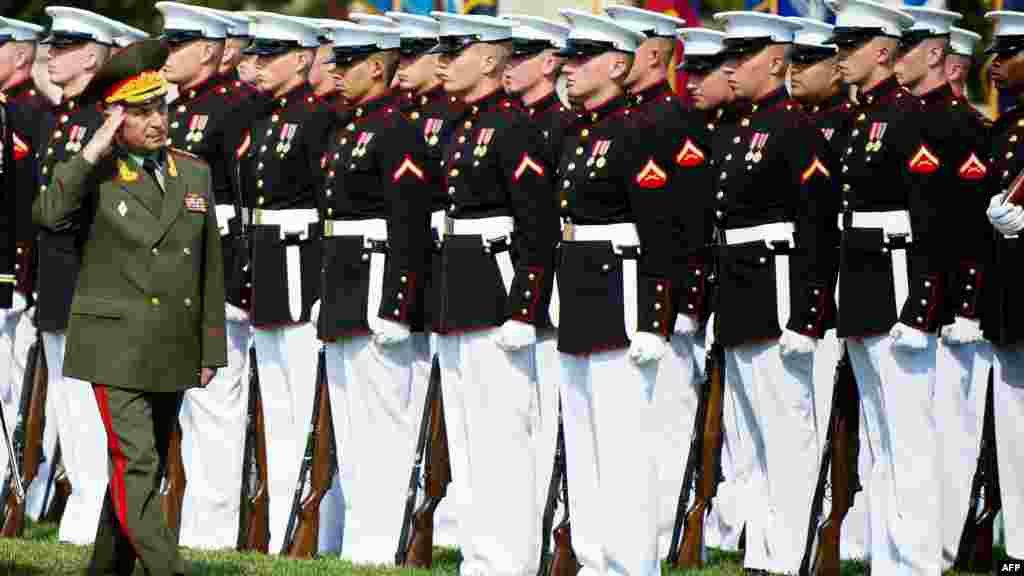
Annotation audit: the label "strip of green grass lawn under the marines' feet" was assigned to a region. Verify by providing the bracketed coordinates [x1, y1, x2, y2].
[0, 524, 1001, 576]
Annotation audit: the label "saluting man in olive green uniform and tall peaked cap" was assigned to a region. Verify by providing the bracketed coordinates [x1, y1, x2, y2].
[33, 41, 226, 575]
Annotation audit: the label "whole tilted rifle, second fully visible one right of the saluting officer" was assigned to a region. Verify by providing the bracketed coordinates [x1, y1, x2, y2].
[281, 346, 337, 558]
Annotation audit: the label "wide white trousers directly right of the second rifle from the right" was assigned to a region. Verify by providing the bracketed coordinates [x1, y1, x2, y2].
[847, 334, 942, 576]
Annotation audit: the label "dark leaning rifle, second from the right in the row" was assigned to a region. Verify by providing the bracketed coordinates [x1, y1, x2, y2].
[800, 345, 860, 576]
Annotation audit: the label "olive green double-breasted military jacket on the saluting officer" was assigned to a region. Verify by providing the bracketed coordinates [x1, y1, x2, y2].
[33, 149, 227, 393]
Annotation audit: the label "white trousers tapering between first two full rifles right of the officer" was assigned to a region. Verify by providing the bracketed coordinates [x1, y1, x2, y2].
[254, 323, 318, 553]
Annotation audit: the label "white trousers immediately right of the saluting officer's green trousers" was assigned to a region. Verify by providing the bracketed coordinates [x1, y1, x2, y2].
[179, 321, 252, 549]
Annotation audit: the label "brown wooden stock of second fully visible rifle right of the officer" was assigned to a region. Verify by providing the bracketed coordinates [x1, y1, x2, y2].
[285, 348, 334, 559]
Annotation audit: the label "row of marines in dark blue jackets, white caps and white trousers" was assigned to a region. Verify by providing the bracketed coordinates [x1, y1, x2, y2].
[2, 0, 1024, 575]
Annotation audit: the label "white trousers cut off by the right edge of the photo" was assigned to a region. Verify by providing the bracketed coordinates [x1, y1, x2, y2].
[992, 342, 1024, 560]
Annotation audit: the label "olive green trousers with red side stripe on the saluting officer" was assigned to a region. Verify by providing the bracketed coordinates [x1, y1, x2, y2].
[89, 384, 184, 576]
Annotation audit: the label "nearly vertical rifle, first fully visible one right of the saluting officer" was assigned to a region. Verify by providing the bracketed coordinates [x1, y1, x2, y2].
[238, 347, 270, 553]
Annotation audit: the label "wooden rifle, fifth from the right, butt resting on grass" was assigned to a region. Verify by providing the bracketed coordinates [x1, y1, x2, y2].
[394, 357, 452, 568]
